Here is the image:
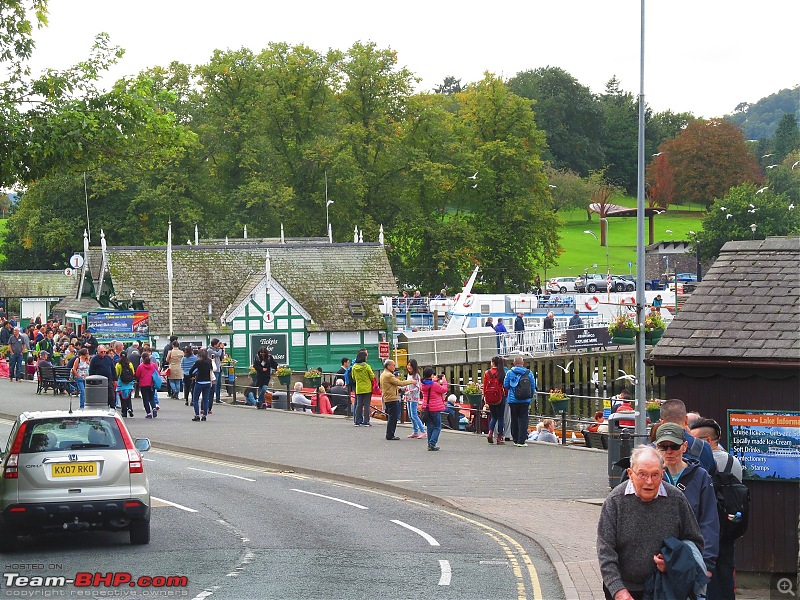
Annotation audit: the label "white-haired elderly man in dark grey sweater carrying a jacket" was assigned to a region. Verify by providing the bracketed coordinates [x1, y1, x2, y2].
[597, 446, 703, 600]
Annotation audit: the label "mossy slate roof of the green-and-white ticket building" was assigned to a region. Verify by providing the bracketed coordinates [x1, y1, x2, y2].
[90, 242, 397, 335]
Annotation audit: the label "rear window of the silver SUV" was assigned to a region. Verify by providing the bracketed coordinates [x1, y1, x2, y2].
[21, 415, 125, 454]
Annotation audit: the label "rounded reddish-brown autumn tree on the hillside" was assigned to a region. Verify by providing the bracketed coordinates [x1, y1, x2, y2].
[660, 119, 763, 205]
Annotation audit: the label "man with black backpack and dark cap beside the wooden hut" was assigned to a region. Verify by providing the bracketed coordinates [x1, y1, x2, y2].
[691, 419, 750, 600]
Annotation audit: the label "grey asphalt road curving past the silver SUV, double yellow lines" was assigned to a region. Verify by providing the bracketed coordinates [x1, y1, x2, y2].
[0, 421, 562, 600]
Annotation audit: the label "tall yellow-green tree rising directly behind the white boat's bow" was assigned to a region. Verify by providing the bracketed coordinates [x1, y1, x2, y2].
[456, 74, 560, 292]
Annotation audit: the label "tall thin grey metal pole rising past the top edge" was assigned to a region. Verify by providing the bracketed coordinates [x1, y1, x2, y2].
[636, 0, 647, 440]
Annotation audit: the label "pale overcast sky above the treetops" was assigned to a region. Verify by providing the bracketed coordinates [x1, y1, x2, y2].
[28, 0, 800, 117]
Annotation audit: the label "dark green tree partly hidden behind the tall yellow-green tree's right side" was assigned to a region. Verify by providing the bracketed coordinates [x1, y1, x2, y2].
[508, 67, 604, 177]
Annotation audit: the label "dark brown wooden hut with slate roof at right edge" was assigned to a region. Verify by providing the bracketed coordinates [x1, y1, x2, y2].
[648, 237, 800, 573]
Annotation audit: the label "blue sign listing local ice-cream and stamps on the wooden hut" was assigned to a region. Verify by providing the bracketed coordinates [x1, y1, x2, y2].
[728, 409, 800, 481]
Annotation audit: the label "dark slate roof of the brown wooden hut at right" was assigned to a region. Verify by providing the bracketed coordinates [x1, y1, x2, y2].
[651, 237, 800, 365]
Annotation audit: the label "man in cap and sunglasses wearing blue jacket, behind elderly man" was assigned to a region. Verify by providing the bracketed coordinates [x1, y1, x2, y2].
[656, 423, 719, 577]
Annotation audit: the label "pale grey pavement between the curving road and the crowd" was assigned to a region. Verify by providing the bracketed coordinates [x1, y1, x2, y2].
[0, 379, 768, 600]
